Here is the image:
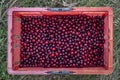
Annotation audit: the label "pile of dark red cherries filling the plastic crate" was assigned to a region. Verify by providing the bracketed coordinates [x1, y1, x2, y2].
[19, 14, 104, 68]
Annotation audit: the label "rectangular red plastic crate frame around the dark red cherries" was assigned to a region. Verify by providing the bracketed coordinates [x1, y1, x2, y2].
[8, 7, 113, 75]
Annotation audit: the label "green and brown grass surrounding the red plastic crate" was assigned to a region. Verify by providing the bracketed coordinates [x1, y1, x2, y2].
[0, 0, 120, 80]
